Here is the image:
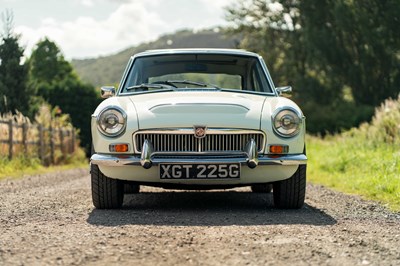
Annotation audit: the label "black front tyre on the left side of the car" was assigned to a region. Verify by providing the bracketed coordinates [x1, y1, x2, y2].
[90, 164, 124, 209]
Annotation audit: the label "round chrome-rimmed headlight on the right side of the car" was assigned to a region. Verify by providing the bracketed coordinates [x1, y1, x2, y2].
[272, 109, 301, 138]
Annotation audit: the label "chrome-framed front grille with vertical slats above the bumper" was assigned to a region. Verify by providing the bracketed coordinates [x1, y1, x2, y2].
[133, 128, 266, 154]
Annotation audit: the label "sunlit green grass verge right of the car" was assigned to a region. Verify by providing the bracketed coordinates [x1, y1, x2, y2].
[307, 134, 400, 211]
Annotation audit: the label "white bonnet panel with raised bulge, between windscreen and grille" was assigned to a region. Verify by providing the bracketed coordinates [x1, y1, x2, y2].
[130, 91, 265, 129]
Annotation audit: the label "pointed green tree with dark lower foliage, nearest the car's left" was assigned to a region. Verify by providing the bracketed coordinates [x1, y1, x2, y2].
[28, 38, 100, 151]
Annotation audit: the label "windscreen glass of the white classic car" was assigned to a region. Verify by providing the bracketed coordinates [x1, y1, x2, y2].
[122, 54, 272, 93]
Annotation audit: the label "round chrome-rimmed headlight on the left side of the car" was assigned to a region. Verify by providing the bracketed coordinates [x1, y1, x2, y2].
[97, 106, 126, 137]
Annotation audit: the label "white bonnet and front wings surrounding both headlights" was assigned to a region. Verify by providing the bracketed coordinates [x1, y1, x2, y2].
[92, 91, 305, 153]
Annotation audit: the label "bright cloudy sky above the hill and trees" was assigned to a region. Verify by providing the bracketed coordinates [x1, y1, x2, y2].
[0, 0, 236, 59]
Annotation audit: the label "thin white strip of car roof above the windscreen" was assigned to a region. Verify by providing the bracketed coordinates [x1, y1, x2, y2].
[133, 48, 260, 57]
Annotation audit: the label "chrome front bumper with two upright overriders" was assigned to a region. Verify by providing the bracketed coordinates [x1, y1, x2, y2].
[90, 139, 307, 169]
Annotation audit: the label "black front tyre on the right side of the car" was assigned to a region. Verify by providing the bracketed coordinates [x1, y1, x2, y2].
[273, 165, 307, 209]
